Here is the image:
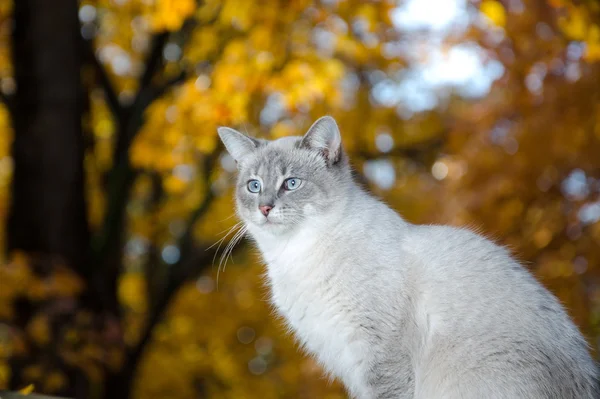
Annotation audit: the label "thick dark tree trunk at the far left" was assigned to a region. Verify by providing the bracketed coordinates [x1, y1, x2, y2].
[8, 0, 89, 271]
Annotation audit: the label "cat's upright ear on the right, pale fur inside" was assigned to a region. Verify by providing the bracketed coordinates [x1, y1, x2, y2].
[301, 116, 342, 165]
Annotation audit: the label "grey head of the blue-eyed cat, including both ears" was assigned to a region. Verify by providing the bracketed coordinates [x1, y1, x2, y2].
[219, 116, 351, 234]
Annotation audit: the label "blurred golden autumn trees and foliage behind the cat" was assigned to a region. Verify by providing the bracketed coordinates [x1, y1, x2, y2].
[0, 0, 600, 399]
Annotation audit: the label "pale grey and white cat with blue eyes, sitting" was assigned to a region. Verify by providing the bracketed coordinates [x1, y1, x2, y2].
[218, 116, 600, 399]
